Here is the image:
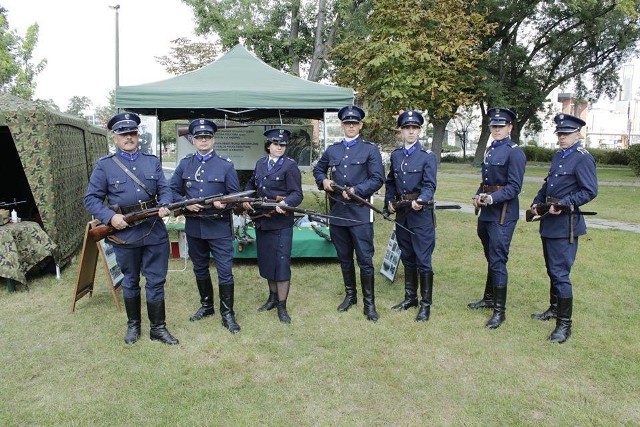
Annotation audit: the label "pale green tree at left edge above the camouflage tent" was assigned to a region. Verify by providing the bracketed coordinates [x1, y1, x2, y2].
[0, 6, 47, 100]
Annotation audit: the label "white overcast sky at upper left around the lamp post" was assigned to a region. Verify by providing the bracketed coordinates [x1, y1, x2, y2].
[0, 0, 195, 110]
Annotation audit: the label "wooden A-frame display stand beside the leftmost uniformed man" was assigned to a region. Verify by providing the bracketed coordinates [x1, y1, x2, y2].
[71, 220, 122, 313]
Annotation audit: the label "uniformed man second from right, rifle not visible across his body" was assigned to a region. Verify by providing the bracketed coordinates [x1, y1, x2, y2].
[468, 108, 527, 329]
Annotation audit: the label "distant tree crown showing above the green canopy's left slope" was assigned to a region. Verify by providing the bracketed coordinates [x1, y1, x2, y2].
[156, 37, 220, 75]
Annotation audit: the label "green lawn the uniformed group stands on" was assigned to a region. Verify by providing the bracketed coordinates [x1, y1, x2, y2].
[0, 172, 640, 426]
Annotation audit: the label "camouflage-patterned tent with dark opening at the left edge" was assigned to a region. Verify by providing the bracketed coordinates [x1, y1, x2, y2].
[0, 94, 108, 265]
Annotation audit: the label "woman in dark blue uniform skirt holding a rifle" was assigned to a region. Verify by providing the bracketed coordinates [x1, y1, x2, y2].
[244, 129, 303, 323]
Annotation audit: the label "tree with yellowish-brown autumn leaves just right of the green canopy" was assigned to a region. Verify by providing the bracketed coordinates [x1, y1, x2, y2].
[332, 0, 492, 159]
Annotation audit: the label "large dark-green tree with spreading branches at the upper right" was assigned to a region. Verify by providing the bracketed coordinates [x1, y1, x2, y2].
[474, 0, 640, 164]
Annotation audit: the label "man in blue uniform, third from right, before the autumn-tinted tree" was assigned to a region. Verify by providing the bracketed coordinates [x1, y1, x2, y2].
[385, 110, 436, 322]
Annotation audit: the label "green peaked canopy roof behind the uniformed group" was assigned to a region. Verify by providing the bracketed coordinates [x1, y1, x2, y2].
[116, 44, 353, 122]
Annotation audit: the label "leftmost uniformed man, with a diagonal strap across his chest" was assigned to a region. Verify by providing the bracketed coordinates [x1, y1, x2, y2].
[84, 113, 178, 344]
